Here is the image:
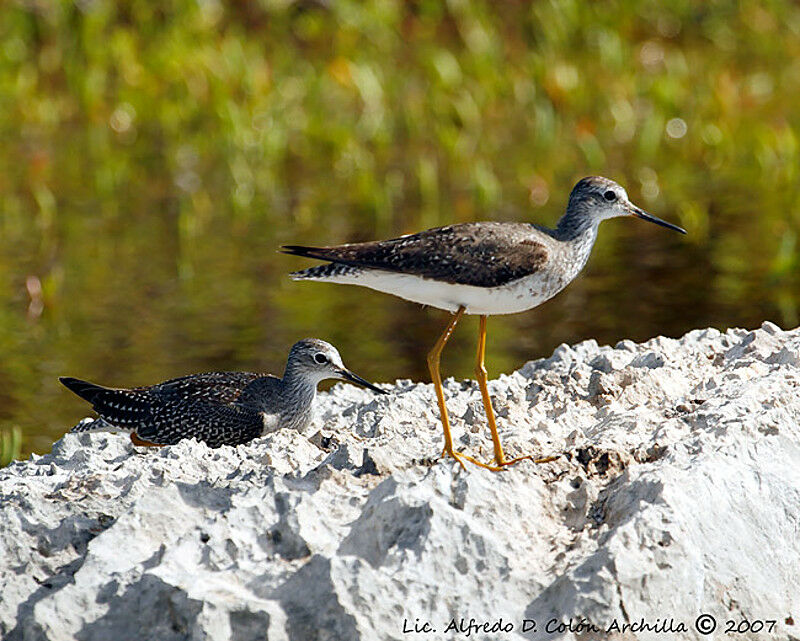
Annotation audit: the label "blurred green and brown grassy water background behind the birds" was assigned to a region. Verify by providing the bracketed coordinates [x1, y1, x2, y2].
[0, 0, 800, 453]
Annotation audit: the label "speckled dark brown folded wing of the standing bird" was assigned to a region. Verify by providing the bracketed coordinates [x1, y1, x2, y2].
[283, 222, 548, 287]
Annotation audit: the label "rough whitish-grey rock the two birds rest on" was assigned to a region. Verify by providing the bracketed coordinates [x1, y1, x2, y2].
[0, 323, 800, 641]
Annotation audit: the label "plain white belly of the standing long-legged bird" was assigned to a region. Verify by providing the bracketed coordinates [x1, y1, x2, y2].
[304, 270, 569, 316]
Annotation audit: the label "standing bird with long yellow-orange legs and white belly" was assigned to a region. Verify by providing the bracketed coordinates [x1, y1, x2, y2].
[282, 176, 686, 471]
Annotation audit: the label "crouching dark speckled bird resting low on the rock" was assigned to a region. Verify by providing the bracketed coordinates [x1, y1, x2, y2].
[59, 338, 386, 447]
